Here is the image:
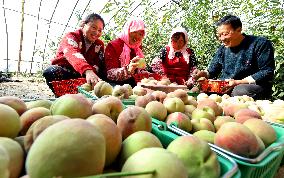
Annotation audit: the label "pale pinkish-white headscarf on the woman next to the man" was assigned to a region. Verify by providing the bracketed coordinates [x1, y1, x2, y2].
[168, 27, 189, 61]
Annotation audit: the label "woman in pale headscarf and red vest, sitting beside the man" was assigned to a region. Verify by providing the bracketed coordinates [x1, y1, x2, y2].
[151, 28, 196, 86]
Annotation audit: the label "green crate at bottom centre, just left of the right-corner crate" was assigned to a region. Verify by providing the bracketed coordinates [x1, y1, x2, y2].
[152, 119, 241, 178]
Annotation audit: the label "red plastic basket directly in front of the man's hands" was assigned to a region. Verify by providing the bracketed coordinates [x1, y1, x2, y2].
[198, 80, 229, 94]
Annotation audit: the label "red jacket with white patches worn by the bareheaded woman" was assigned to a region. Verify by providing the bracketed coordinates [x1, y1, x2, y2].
[51, 29, 104, 75]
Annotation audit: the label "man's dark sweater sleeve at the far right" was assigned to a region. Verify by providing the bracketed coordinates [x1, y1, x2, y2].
[251, 40, 275, 84]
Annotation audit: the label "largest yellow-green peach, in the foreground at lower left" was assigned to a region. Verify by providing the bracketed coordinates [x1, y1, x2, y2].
[26, 119, 105, 178]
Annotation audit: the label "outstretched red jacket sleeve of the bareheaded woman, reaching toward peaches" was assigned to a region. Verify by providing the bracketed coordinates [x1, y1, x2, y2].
[60, 33, 93, 75]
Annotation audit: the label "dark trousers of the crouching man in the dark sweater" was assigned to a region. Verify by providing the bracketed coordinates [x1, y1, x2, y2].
[231, 84, 272, 99]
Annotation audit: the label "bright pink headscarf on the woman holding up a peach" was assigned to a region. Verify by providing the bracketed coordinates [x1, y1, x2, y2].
[119, 19, 145, 67]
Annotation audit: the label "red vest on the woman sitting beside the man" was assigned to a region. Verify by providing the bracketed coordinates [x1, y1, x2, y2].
[162, 46, 192, 85]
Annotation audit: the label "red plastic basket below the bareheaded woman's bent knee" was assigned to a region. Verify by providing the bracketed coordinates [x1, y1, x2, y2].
[51, 78, 86, 97]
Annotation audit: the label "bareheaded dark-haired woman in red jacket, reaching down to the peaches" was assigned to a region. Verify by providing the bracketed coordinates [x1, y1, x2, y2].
[43, 13, 105, 92]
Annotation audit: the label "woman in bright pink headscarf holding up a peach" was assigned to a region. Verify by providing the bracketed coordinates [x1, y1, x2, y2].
[105, 19, 145, 85]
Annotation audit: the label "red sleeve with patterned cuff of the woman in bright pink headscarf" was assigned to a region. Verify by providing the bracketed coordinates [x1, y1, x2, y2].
[105, 43, 132, 81]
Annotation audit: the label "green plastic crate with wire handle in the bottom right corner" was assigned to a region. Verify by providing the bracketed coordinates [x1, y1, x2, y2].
[168, 124, 284, 178]
